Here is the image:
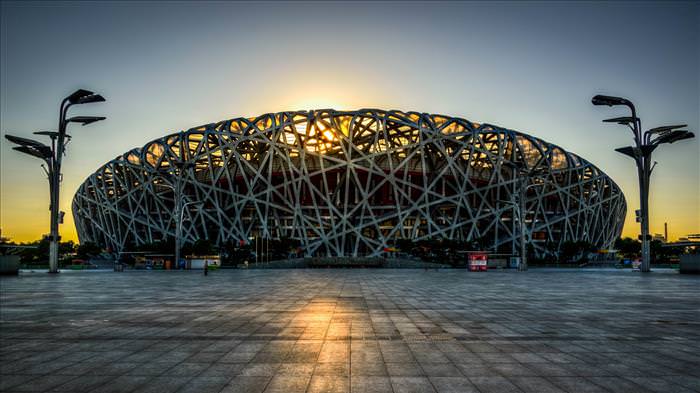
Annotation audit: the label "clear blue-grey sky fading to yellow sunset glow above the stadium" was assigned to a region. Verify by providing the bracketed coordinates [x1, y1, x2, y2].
[0, 1, 700, 241]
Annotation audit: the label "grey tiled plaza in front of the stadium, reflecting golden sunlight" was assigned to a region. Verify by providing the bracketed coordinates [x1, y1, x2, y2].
[0, 269, 700, 393]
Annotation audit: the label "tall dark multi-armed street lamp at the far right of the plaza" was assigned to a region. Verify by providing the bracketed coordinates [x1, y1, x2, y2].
[591, 95, 695, 272]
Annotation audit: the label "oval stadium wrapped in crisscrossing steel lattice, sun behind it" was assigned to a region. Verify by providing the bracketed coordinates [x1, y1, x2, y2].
[73, 109, 626, 256]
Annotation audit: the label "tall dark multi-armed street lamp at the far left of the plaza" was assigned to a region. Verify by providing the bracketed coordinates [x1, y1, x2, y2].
[5, 89, 105, 273]
